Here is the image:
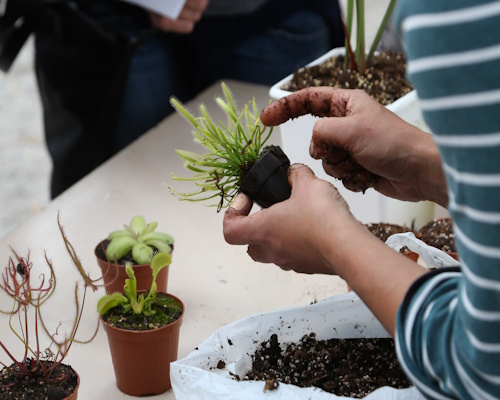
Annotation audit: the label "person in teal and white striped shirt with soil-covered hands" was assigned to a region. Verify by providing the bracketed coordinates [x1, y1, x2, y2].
[224, 0, 500, 400]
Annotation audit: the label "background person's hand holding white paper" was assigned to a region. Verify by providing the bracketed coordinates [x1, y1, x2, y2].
[149, 0, 209, 34]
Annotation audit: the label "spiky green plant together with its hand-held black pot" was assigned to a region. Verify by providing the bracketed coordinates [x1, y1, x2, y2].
[170, 83, 290, 211]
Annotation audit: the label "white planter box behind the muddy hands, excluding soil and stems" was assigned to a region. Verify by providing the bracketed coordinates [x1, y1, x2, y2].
[269, 48, 434, 229]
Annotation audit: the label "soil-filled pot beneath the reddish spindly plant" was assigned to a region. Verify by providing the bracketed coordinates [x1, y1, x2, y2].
[0, 359, 78, 400]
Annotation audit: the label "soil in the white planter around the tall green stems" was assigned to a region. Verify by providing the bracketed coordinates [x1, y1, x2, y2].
[282, 52, 412, 105]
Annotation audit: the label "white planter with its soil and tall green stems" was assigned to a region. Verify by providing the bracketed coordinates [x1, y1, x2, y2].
[269, 0, 434, 229]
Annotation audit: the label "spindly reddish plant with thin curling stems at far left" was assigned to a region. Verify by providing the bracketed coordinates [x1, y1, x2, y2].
[0, 217, 99, 388]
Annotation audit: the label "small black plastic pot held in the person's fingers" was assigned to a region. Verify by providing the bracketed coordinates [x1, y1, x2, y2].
[240, 146, 292, 208]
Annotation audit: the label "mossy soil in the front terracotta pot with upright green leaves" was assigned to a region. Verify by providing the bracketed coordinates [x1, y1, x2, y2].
[102, 293, 182, 331]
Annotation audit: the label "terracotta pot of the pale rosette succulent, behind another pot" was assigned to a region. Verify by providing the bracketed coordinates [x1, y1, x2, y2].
[94, 242, 170, 294]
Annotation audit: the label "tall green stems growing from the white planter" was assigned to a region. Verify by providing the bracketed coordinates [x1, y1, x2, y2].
[344, 0, 396, 72]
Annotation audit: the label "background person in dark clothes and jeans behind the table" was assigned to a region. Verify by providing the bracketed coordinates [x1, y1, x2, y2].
[35, 0, 344, 197]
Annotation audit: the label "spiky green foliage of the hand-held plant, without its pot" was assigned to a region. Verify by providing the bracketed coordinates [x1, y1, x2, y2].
[169, 83, 272, 211]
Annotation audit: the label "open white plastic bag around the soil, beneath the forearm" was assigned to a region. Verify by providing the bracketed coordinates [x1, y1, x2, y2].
[170, 292, 423, 400]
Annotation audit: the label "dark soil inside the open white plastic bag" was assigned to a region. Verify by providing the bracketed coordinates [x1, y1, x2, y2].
[243, 333, 411, 398]
